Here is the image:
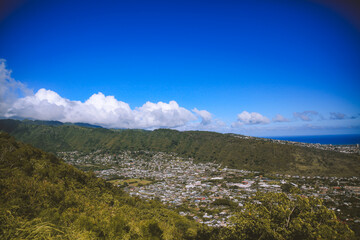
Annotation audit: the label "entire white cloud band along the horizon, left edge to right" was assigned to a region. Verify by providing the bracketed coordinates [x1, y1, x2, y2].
[0, 59, 360, 135]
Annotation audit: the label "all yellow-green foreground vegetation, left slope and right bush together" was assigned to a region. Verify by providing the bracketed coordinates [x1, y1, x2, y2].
[0, 133, 354, 239]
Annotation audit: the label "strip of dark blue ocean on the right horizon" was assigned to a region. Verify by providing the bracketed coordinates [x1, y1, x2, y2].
[265, 134, 360, 145]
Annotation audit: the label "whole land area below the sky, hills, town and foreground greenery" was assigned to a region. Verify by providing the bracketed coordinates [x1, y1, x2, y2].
[0, 119, 360, 239]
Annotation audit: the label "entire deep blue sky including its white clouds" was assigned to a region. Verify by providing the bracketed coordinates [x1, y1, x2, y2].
[0, 0, 360, 136]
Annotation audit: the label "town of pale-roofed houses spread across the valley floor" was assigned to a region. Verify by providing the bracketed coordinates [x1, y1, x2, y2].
[58, 146, 360, 229]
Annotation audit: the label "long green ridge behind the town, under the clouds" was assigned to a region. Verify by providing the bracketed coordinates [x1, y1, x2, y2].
[0, 119, 360, 176]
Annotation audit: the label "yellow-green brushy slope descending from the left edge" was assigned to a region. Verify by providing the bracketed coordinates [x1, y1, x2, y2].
[0, 133, 205, 239]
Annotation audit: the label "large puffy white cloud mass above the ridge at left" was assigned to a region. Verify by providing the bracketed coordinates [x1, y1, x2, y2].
[0, 60, 200, 129]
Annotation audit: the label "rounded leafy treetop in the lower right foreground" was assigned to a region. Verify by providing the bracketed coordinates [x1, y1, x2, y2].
[220, 193, 355, 240]
